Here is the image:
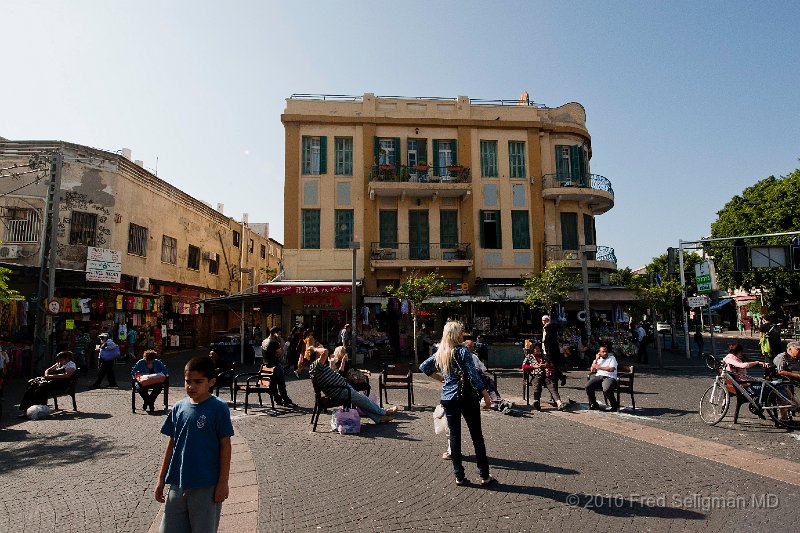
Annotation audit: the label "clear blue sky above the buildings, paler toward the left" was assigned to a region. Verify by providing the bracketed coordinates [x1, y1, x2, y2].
[0, 0, 800, 268]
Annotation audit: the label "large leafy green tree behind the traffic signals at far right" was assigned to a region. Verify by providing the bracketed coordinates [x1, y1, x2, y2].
[709, 169, 800, 312]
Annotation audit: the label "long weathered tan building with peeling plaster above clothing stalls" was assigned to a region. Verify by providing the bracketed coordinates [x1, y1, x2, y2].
[0, 140, 282, 354]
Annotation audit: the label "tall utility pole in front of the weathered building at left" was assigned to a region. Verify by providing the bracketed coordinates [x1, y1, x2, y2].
[31, 152, 64, 375]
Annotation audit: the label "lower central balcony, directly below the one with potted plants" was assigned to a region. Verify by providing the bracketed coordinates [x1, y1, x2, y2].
[369, 242, 472, 270]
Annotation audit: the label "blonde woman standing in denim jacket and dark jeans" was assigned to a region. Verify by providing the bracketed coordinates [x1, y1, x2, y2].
[419, 321, 497, 486]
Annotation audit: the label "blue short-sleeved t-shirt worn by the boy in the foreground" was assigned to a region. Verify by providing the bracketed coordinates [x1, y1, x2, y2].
[161, 396, 233, 489]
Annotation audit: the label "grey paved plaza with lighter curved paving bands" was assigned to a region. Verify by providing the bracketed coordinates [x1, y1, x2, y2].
[0, 334, 800, 532]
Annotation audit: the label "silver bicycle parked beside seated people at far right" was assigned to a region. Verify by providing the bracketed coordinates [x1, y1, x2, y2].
[700, 355, 800, 430]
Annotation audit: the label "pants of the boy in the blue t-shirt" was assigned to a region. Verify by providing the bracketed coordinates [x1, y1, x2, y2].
[159, 485, 222, 533]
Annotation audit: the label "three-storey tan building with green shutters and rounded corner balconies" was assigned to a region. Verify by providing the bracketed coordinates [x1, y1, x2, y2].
[281, 93, 616, 344]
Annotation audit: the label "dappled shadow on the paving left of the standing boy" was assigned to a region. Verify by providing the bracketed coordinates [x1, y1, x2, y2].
[0, 433, 120, 473]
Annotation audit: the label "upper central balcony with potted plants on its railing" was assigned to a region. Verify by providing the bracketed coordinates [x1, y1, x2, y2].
[369, 164, 472, 199]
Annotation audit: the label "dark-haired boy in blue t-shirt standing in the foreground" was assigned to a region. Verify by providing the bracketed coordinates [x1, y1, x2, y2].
[154, 356, 233, 533]
